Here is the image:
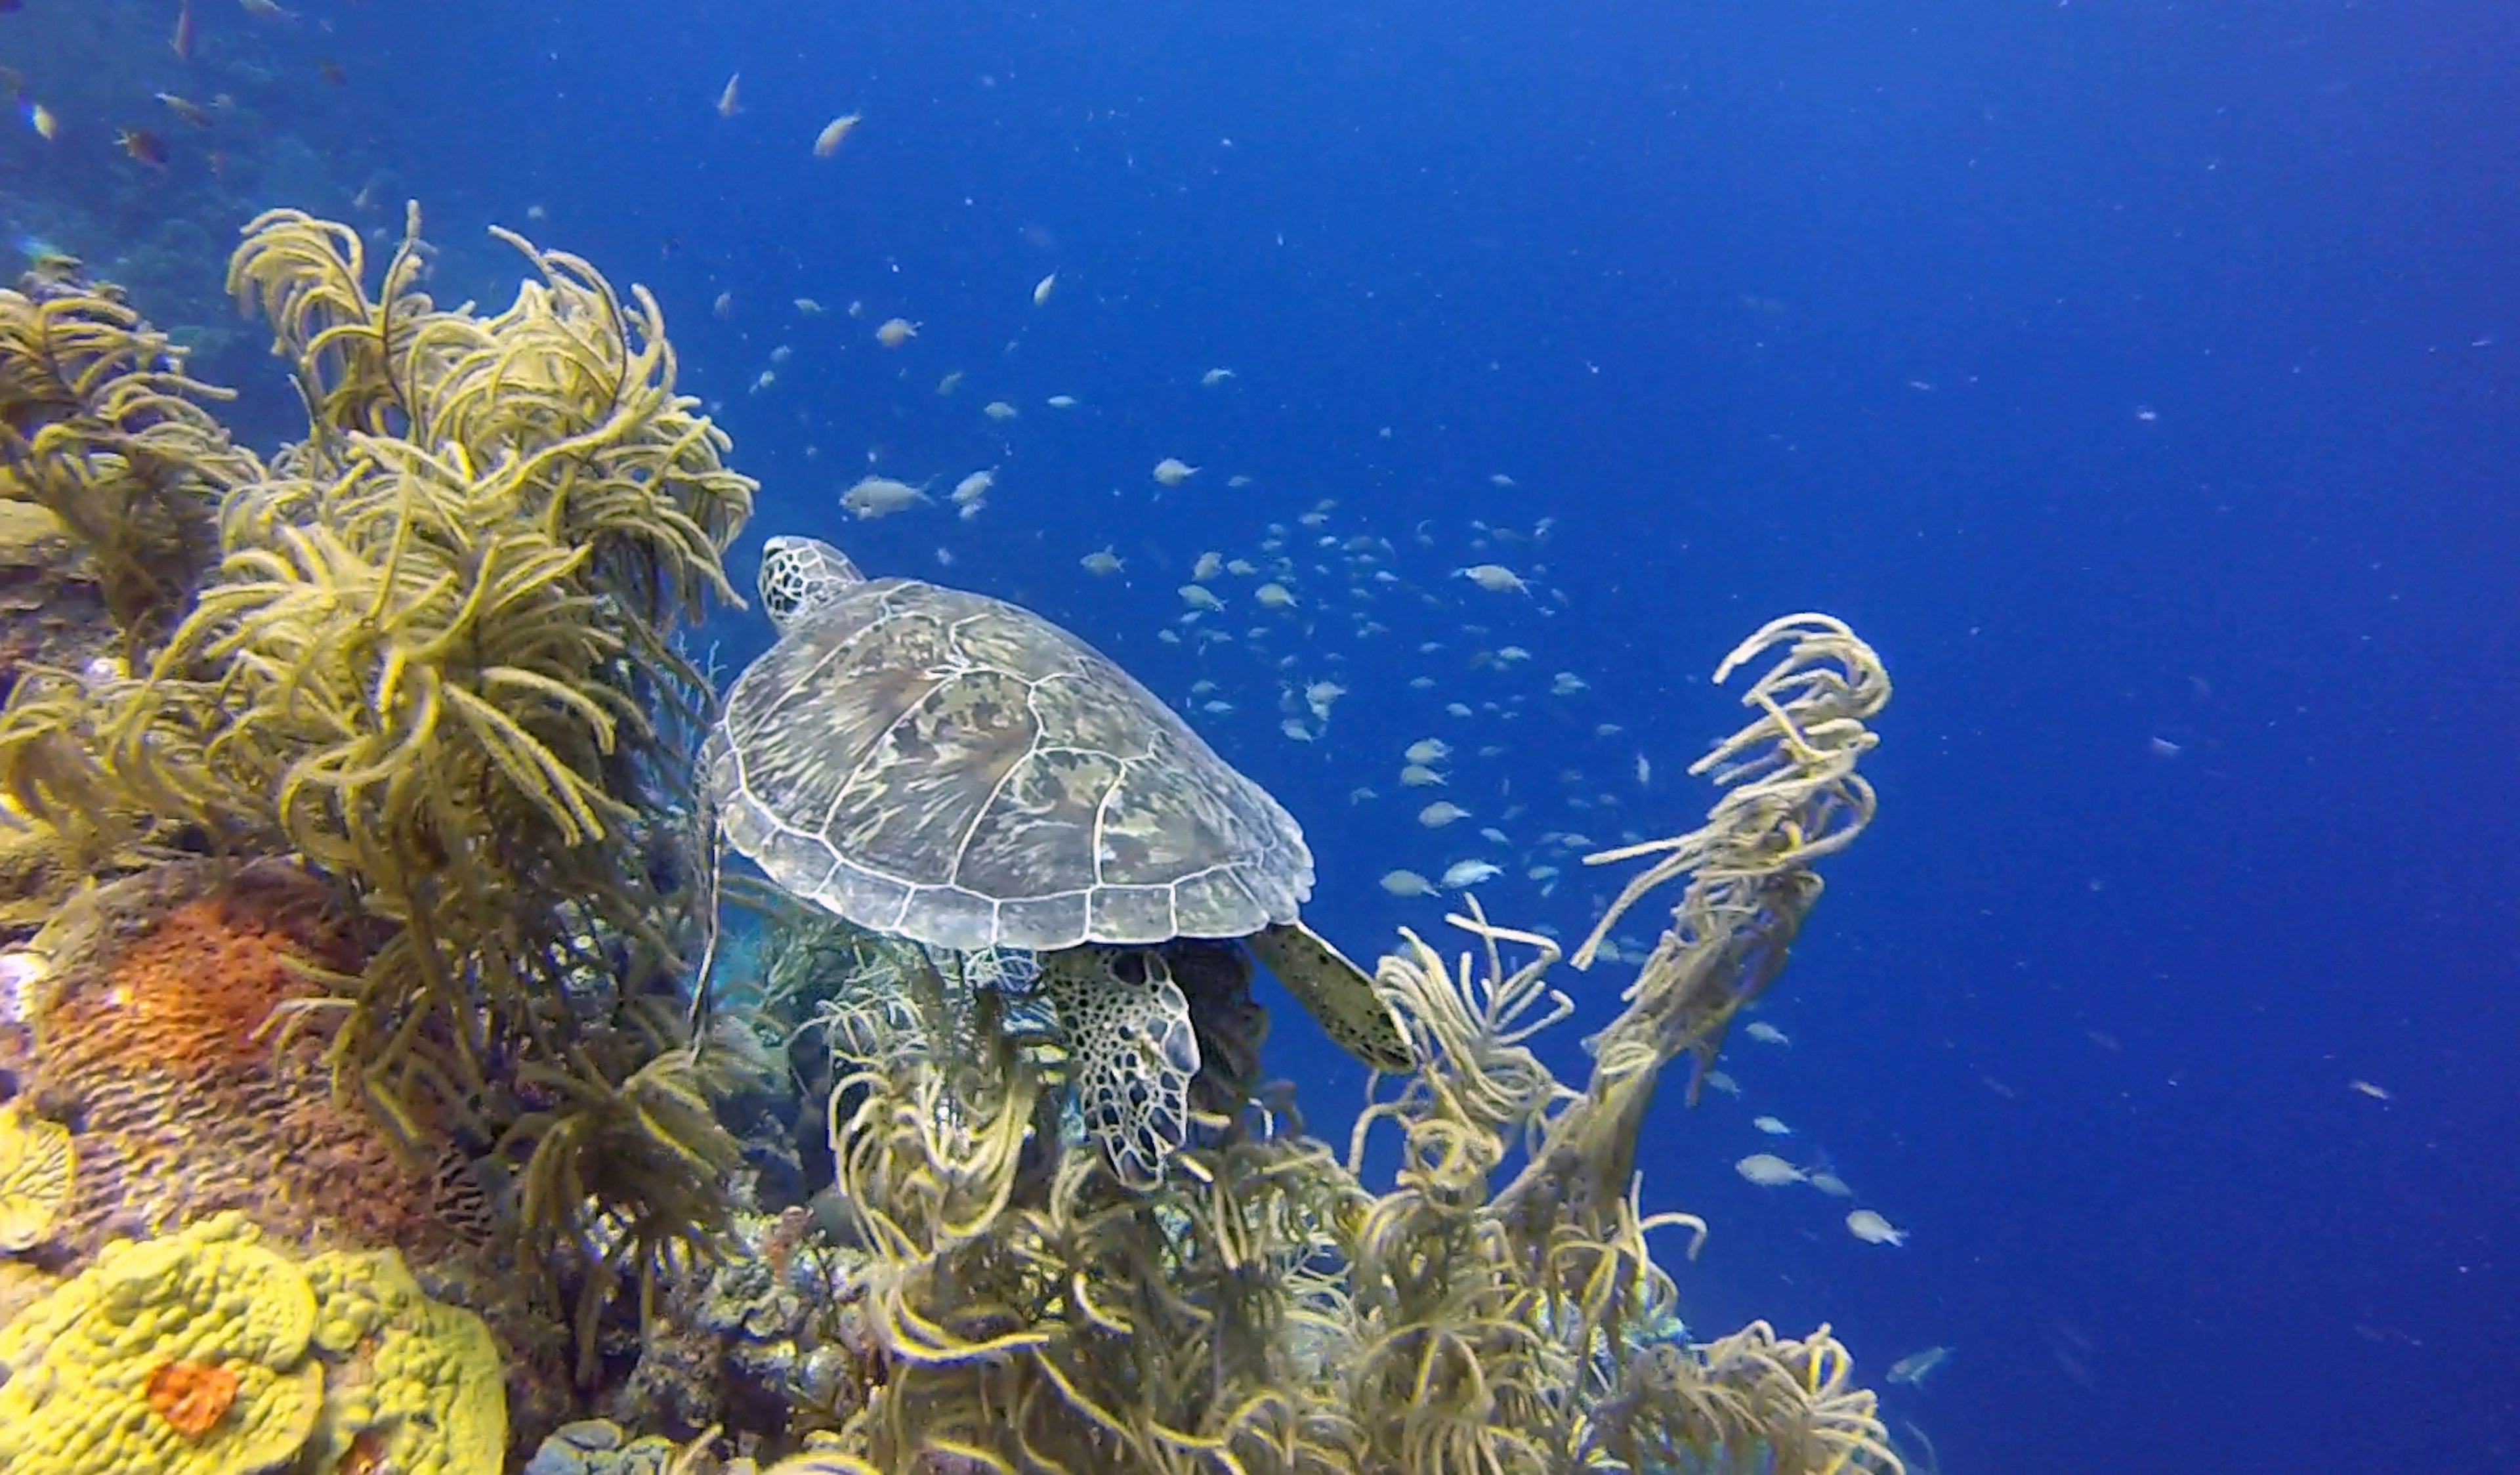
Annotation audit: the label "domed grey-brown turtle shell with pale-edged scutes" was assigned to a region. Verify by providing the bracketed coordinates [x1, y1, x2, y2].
[701, 580, 1313, 951]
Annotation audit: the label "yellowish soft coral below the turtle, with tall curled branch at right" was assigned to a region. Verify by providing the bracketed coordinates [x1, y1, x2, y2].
[801, 618, 1898, 1475]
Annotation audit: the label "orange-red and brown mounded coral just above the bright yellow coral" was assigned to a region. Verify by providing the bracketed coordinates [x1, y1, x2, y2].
[0, 863, 481, 1261]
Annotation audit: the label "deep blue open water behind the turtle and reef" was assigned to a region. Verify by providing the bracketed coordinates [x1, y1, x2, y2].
[0, 0, 2520, 1475]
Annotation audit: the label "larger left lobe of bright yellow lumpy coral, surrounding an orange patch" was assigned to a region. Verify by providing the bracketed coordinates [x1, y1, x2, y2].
[0, 1215, 325, 1475]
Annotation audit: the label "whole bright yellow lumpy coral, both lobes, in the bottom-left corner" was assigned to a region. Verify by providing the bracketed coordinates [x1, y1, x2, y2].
[0, 1213, 507, 1475]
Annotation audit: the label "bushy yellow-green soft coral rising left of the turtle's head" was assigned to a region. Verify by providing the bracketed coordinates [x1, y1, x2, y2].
[0, 209, 753, 1361]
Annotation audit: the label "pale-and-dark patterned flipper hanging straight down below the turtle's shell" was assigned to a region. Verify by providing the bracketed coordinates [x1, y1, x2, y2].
[1041, 945, 1200, 1193]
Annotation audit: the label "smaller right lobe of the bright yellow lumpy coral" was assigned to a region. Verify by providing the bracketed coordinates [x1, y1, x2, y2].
[307, 1251, 507, 1475]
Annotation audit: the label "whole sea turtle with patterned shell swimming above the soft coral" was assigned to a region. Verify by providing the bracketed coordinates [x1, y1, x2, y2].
[701, 537, 1411, 1185]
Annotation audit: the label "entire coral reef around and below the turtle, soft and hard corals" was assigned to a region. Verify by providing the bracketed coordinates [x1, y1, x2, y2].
[0, 198, 1900, 1475]
